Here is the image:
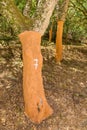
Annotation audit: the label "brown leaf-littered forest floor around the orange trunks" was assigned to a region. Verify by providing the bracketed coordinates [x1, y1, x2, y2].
[0, 41, 87, 130]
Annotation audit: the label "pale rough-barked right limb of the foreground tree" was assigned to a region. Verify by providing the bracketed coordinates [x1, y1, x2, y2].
[30, 0, 58, 35]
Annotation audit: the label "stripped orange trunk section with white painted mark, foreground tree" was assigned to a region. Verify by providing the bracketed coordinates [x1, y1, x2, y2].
[19, 31, 53, 123]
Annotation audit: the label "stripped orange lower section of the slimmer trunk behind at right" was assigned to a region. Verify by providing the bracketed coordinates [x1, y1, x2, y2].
[56, 21, 64, 62]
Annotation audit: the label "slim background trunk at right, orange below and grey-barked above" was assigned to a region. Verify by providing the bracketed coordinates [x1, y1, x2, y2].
[56, 0, 70, 62]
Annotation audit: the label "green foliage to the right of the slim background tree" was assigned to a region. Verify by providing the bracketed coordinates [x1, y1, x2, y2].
[64, 0, 87, 41]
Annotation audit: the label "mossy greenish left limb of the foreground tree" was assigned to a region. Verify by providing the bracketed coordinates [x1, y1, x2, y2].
[0, 0, 30, 32]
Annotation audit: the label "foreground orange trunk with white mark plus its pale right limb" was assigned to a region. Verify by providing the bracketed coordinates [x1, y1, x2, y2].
[19, 0, 57, 123]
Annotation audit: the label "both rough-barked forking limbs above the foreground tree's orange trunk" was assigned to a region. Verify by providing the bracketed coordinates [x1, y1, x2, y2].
[0, 0, 58, 35]
